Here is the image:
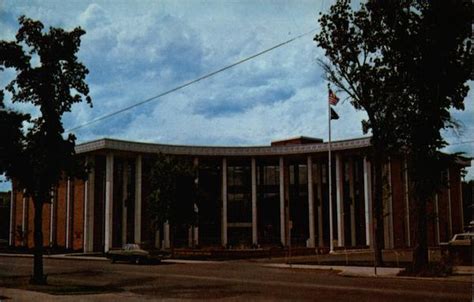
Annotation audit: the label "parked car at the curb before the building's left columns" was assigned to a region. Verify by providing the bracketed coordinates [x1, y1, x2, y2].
[106, 243, 167, 264]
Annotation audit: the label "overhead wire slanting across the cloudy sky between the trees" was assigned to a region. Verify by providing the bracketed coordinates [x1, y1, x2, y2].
[66, 29, 316, 133]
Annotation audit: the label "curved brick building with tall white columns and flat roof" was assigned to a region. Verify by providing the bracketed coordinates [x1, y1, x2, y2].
[10, 137, 470, 253]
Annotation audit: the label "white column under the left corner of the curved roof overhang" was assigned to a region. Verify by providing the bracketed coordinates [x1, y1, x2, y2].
[83, 158, 95, 253]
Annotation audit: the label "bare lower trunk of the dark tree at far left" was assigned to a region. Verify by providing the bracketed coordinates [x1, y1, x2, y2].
[30, 200, 46, 284]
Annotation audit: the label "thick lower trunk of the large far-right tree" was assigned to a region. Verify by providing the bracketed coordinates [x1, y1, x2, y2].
[413, 198, 428, 273]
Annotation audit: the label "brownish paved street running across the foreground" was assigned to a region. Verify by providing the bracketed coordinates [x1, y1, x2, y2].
[0, 257, 472, 302]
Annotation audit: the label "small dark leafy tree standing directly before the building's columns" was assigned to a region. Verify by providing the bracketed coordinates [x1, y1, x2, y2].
[147, 154, 197, 254]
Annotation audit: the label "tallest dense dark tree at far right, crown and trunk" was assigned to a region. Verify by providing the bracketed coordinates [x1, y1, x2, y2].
[384, 0, 473, 272]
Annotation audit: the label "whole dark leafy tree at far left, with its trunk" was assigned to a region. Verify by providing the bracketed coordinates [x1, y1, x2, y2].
[0, 16, 92, 284]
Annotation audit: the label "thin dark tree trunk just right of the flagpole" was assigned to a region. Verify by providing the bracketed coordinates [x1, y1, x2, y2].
[372, 148, 383, 266]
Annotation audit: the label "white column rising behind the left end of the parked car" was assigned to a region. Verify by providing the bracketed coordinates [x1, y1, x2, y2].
[104, 153, 114, 252]
